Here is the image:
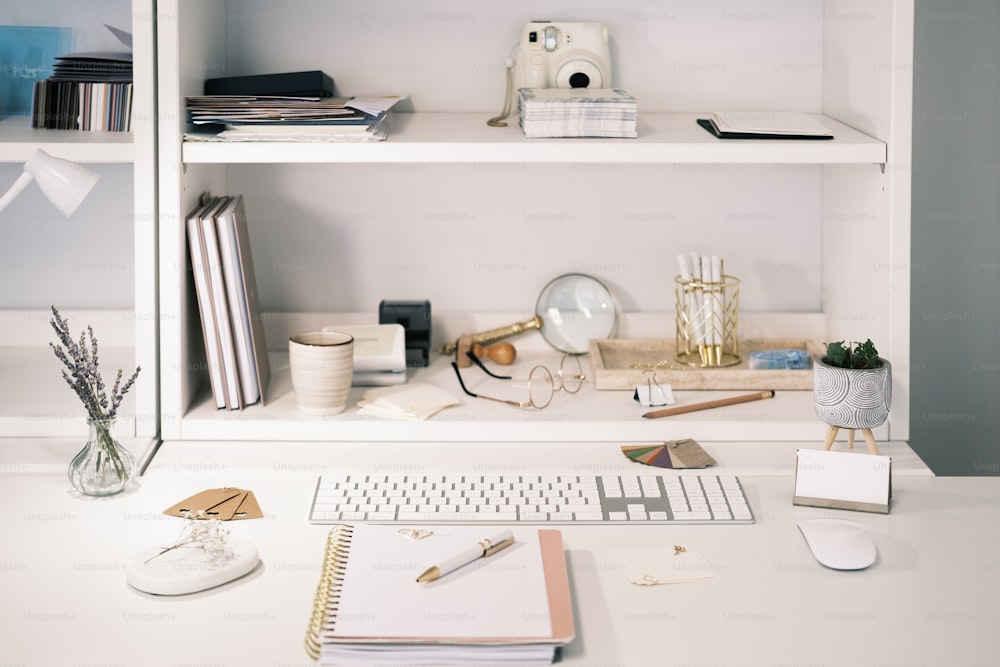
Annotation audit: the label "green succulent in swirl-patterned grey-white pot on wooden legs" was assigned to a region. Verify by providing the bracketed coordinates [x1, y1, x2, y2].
[813, 339, 892, 454]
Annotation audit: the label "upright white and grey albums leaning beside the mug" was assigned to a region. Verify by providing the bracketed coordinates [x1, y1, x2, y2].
[187, 195, 271, 410]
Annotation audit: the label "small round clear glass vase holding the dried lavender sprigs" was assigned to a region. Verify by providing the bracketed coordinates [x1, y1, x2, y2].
[69, 419, 135, 496]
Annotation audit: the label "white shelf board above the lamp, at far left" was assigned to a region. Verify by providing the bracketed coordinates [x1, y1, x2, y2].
[0, 116, 135, 164]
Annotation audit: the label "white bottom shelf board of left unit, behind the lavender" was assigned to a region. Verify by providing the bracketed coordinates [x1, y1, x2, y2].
[0, 345, 135, 443]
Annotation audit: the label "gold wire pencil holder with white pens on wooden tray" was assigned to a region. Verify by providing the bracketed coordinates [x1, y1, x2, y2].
[674, 274, 740, 368]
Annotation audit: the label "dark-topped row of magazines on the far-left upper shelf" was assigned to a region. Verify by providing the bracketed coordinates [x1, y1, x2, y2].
[32, 52, 132, 132]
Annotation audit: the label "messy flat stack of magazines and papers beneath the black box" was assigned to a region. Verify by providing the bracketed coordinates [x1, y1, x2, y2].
[185, 95, 400, 141]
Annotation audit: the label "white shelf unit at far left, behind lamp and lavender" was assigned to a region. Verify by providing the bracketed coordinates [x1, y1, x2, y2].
[0, 0, 160, 470]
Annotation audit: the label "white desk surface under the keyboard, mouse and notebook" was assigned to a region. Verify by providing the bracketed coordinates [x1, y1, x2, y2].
[0, 443, 1000, 667]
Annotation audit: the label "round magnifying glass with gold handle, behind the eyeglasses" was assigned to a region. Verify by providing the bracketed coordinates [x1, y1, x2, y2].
[441, 273, 618, 354]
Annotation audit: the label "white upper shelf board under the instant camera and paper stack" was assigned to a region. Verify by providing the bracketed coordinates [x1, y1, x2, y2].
[183, 113, 887, 164]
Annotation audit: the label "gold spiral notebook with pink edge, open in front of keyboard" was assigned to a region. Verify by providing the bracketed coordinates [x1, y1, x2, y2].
[306, 524, 574, 665]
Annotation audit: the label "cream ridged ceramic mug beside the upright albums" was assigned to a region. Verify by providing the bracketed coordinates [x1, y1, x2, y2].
[288, 331, 354, 417]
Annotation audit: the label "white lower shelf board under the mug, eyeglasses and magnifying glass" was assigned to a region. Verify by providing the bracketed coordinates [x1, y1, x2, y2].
[181, 350, 887, 442]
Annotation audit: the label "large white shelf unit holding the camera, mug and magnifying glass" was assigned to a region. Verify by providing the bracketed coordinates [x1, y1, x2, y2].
[159, 0, 913, 442]
